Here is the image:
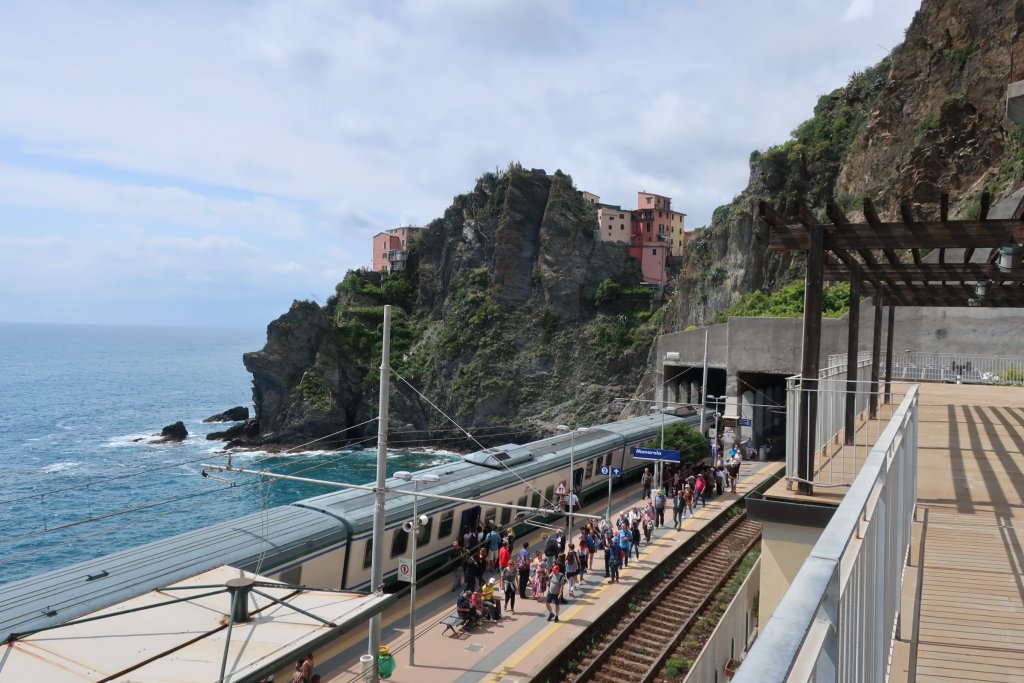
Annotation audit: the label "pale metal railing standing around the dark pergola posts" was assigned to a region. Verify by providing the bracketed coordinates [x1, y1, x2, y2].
[785, 354, 906, 486]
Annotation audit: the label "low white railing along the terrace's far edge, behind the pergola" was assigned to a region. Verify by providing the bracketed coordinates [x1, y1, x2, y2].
[828, 352, 1024, 385]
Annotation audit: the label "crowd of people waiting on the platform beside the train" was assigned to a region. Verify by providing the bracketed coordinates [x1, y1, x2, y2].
[449, 449, 742, 628]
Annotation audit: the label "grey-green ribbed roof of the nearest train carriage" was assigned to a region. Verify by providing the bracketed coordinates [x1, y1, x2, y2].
[0, 505, 345, 638]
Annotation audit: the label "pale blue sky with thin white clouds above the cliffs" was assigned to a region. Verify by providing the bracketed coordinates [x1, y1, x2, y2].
[0, 0, 920, 329]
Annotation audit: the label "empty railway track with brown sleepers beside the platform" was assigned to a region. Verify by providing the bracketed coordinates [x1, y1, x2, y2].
[569, 513, 761, 683]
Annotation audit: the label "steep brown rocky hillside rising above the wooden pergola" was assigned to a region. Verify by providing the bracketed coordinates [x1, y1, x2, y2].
[674, 0, 1024, 328]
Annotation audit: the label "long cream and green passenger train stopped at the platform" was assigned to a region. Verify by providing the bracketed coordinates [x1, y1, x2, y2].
[0, 411, 713, 635]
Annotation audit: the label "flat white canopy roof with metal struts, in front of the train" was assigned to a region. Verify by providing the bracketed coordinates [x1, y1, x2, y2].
[0, 565, 394, 683]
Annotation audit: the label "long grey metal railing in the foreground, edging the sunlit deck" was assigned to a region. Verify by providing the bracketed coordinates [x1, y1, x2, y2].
[732, 386, 919, 683]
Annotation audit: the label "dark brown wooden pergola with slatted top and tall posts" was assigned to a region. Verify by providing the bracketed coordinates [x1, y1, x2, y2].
[760, 193, 1024, 495]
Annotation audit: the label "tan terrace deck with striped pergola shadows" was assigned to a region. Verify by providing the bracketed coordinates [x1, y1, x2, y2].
[891, 384, 1024, 682]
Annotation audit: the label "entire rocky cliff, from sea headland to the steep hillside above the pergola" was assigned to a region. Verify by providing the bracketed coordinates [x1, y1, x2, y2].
[239, 0, 1024, 447]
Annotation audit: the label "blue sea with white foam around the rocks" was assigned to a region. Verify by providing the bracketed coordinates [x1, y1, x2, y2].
[0, 323, 459, 584]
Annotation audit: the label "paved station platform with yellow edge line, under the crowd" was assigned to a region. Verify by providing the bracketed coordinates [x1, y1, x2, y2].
[307, 461, 783, 683]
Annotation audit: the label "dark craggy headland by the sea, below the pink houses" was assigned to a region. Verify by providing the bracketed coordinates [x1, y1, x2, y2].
[244, 166, 657, 446]
